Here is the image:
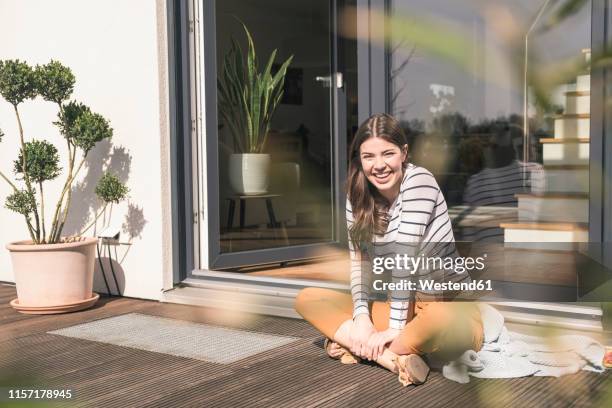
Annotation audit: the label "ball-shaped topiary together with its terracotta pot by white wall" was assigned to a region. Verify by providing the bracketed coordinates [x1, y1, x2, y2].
[0, 60, 128, 313]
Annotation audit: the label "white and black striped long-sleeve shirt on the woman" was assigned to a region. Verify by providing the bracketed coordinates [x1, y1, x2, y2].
[346, 164, 470, 329]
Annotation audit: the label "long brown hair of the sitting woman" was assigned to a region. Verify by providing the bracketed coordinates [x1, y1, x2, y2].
[346, 113, 408, 246]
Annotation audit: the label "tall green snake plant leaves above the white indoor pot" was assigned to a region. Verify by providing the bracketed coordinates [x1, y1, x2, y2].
[217, 24, 293, 153]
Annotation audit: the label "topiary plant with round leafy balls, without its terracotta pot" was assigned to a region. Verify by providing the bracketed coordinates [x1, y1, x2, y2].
[0, 60, 128, 244]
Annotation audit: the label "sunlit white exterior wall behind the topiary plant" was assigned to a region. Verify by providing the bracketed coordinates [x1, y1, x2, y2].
[0, 0, 171, 299]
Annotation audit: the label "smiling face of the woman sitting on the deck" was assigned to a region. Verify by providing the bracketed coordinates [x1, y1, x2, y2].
[359, 137, 408, 201]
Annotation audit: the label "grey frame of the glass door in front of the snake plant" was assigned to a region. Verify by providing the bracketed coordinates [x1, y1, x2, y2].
[194, 0, 347, 270]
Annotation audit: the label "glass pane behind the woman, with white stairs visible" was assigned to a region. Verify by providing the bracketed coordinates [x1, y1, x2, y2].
[388, 0, 601, 301]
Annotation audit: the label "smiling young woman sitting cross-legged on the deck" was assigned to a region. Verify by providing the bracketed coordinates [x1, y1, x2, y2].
[295, 114, 483, 385]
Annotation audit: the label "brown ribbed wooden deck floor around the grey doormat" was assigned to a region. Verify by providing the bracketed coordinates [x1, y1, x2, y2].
[0, 285, 612, 408]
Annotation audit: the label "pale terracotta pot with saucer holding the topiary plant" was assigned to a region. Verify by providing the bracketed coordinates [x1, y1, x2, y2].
[6, 238, 99, 314]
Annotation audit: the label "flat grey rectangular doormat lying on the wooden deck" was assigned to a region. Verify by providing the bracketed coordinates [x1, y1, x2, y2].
[48, 313, 298, 364]
